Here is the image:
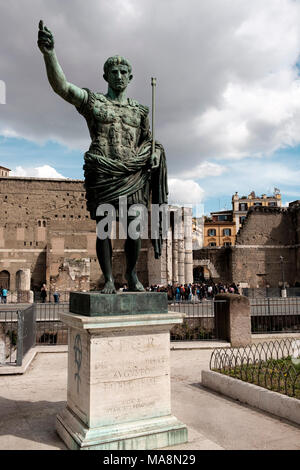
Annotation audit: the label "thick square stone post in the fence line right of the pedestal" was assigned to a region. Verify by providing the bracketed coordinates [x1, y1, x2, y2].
[215, 294, 251, 347]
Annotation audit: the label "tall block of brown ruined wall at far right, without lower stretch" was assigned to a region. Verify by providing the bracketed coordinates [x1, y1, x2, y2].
[232, 207, 297, 287]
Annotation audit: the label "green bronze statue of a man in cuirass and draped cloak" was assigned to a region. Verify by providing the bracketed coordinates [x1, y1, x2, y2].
[38, 21, 168, 294]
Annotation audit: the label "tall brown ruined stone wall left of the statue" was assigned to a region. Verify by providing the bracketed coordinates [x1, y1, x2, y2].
[0, 177, 101, 291]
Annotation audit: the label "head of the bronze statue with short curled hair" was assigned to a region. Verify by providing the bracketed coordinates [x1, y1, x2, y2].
[103, 55, 133, 90]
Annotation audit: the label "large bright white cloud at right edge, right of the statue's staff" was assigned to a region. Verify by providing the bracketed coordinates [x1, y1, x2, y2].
[195, 72, 300, 159]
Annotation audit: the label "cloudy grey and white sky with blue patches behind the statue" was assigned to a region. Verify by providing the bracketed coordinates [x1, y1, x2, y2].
[0, 0, 300, 213]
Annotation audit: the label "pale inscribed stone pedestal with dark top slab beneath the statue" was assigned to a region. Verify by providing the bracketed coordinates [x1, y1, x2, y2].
[57, 293, 187, 450]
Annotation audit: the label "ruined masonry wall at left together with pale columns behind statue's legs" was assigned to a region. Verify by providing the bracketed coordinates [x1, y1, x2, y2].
[0, 176, 193, 291]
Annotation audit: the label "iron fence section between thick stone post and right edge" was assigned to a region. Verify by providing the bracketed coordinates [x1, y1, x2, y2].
[250, 297, 300, 334]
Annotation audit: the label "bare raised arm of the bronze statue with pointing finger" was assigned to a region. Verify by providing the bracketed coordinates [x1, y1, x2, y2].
[38, 20, 87, 107]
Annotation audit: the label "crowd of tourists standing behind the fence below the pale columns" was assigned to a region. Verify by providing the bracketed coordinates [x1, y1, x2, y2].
[121, 281, 239, 302]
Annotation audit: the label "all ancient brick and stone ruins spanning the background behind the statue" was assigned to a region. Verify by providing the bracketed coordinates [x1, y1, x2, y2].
[0, 177, 300, 292]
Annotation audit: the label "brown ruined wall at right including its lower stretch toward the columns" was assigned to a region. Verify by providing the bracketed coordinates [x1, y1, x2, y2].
[194, 204, 300, 288]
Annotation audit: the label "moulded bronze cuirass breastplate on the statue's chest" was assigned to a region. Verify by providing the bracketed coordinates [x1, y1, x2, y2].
[90, 98, 141, 160]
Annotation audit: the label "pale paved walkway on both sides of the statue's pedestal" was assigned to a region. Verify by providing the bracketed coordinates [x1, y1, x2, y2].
[0, 349, 300, 450]
